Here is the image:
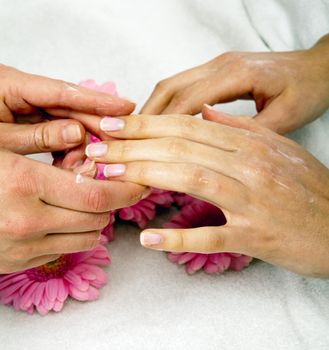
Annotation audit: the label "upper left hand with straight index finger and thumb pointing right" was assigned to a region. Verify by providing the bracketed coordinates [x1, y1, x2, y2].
[0, 65, 135, 154]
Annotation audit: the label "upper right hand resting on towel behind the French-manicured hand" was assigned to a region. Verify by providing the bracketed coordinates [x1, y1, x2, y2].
[141, 34, 329, 134]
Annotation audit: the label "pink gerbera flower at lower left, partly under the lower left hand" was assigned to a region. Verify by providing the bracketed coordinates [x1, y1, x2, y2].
[0, 237, 110, 315]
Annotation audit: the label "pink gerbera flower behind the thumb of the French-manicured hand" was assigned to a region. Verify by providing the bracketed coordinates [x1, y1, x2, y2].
[164, 195, 252, 274]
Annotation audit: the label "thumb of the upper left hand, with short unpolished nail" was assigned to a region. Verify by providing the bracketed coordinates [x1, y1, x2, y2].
[0, 119, 85, 154]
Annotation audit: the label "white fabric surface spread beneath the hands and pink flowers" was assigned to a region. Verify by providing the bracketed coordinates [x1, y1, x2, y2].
[0, 0, 329, 350]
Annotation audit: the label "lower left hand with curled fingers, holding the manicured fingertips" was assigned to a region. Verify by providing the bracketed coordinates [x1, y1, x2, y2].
[0, 150, 144, 274]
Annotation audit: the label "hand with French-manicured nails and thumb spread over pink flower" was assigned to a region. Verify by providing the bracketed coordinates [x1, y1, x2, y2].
[86, 109, 329, 276]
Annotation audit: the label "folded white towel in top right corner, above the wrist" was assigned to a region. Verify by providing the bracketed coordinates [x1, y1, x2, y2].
[243, 0, 329, 51]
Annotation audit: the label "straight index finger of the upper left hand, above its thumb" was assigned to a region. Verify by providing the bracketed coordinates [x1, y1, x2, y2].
[18, 72, 135, 115]
